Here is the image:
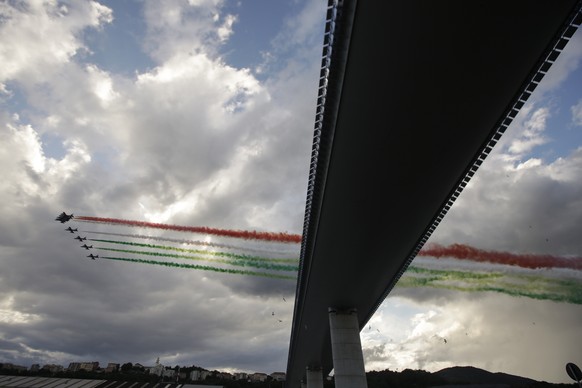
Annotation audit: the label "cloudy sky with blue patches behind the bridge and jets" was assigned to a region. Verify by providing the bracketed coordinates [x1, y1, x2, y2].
[0, 0, 582, 383]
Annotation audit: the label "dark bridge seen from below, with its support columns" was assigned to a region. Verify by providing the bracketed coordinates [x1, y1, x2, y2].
[286, 0, 582, 388]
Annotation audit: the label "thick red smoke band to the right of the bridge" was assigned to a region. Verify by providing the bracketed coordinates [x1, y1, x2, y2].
[418, 244, 582, 270]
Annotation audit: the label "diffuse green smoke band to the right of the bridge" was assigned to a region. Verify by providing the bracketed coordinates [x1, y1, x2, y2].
[397, 266, 582, 304]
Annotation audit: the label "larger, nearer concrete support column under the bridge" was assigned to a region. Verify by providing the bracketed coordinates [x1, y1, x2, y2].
[329, 308, 368, 388]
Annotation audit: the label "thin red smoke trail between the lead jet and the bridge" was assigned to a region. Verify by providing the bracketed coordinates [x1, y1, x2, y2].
[75, 216, 301, 243]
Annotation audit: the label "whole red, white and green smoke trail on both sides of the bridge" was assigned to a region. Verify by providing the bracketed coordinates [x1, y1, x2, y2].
[64, 212, 582, 304]
